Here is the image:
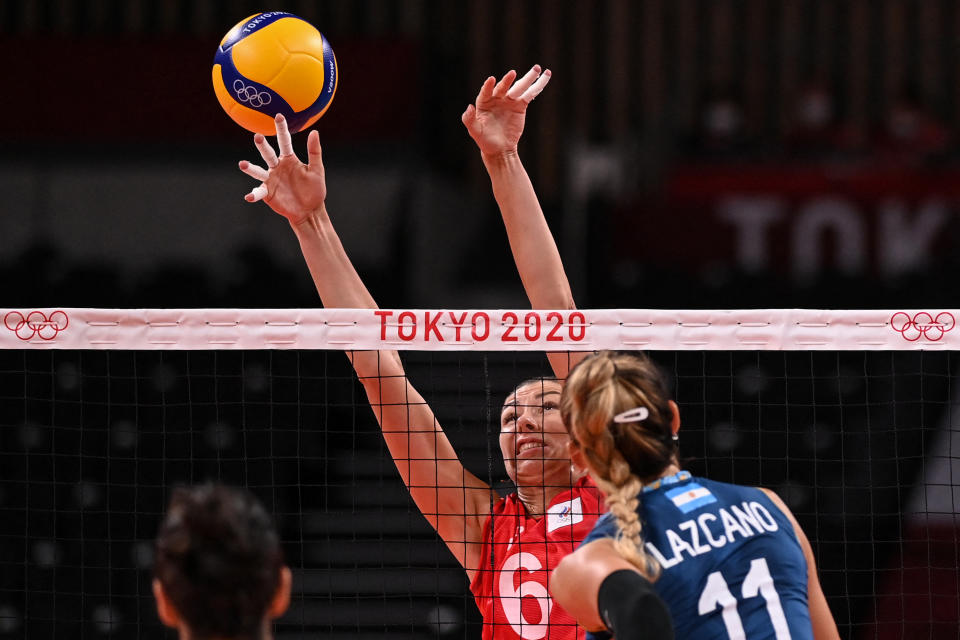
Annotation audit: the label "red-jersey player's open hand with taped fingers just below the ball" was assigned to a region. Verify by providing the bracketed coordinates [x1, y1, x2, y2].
[240, 114, 327, 224]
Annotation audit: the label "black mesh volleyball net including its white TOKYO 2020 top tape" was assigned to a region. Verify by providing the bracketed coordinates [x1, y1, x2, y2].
[0, 309, 960, 640]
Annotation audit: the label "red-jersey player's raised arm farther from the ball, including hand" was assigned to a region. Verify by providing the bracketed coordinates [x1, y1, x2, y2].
[462, 65, 583, 379]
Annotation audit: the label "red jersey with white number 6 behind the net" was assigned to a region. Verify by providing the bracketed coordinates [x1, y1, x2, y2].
[470, 477, 606, 640]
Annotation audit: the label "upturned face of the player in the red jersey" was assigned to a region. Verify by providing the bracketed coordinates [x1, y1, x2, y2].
[500, 380, 570, 486]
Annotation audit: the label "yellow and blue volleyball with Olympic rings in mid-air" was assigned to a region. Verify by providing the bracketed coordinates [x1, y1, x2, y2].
[213, 11, 337, 135]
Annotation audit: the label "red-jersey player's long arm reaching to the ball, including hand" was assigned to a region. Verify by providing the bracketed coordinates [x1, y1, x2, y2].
[240, 115, 491, 579]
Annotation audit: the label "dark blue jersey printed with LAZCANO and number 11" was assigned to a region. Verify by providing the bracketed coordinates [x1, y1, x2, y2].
[582, 471, 813, 640]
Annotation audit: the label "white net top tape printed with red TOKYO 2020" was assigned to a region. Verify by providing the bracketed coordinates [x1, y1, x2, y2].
[0, 308, 960, 351]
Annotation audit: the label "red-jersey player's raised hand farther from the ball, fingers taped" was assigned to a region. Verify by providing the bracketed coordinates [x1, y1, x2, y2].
[461, 64, 550, 155]
